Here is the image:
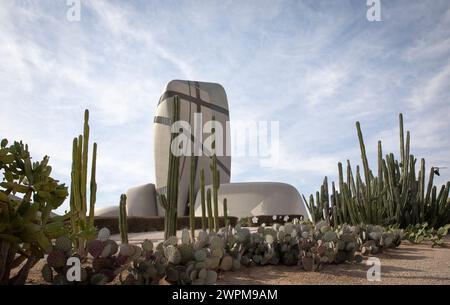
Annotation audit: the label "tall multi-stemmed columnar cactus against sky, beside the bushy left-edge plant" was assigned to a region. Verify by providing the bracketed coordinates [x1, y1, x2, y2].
[70, 109, 97, 254]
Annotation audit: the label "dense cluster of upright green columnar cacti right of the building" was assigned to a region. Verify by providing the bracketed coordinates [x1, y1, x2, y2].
[303, 114, 450, 228]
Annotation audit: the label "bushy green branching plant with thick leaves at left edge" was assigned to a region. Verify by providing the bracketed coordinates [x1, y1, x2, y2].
[0, 139, 68, 285]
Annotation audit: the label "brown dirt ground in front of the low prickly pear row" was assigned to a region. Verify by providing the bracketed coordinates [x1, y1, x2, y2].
[27, 236, 450, 285]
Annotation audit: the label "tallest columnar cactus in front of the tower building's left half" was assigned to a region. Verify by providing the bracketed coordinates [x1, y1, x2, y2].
[158, 96, 180, 239]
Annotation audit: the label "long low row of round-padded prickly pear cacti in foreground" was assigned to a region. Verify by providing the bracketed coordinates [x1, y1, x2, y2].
[37, 219, 414, 285]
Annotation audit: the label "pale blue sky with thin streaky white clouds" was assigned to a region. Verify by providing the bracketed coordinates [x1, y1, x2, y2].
[0, 0, 450, 211]
